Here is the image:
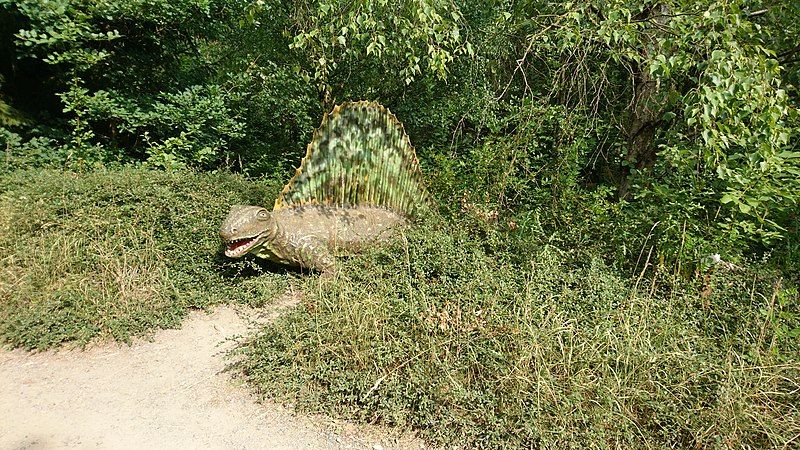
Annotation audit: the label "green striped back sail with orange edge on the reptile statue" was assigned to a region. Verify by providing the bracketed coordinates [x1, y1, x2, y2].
[274, 101, 427, 216]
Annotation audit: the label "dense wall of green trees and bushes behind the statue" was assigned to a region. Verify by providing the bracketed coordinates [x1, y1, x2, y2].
[3, 0, 800, 260]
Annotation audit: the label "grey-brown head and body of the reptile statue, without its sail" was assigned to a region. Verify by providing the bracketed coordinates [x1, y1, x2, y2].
[220, 205, 406, 271]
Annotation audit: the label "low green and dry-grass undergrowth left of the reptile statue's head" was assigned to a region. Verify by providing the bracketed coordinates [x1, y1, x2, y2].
[0, 168, 286, 349]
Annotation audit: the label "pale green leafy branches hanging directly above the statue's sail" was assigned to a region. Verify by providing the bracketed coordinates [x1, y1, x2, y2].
[268, 0, 473, 95]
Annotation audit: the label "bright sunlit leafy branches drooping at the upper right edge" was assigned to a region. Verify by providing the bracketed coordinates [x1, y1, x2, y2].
[664, 3, 800, 240]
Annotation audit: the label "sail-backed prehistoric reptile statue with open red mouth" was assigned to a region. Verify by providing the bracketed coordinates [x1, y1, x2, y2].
[220, 101, 427, 272]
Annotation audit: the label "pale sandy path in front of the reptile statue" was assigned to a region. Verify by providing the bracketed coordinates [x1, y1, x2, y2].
[0, 300, 424, 449]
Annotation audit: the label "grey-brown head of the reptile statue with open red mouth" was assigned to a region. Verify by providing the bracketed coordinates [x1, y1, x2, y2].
[219, 205, 275, 258]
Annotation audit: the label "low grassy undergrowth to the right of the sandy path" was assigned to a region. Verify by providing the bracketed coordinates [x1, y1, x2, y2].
[238, 220, 800, 448]
